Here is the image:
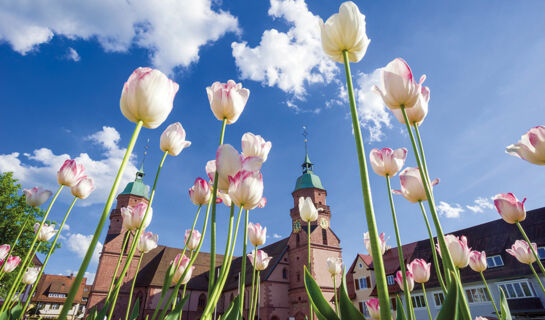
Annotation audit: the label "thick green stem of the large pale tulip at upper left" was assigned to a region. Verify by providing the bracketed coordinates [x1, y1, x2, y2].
[58, 120, 144, 320]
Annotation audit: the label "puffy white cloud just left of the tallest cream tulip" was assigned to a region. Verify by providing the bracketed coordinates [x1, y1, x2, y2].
[231, 0, 338, 99]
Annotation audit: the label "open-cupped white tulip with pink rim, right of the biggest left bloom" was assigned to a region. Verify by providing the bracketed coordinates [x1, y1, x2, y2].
[206, 80, 250, 124]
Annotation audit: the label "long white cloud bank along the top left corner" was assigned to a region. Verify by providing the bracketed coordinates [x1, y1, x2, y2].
[0, 0, 239, 72]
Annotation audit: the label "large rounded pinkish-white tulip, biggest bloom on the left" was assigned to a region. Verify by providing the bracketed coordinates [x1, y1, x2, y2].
[119, 67, 179, 129]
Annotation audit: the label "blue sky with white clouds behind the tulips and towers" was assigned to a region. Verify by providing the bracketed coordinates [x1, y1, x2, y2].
[0, 0, 545, 282]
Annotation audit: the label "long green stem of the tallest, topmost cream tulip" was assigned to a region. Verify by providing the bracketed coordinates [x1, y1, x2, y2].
[343, 50, 392, 319]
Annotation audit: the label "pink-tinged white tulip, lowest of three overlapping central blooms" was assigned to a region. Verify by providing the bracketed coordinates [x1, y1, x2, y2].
[229, 170, 263, 210]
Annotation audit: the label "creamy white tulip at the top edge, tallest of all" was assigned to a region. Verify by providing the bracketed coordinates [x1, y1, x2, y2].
[320, 1, 371, 63]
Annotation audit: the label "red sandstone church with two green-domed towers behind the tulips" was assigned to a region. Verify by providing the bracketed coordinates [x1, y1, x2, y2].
[87, 153, 341, 320]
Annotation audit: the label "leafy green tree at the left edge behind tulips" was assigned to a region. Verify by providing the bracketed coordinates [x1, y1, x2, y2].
[0, 172, 59, 296]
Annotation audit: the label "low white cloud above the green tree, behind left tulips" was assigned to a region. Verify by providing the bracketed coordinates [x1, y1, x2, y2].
[0, 127, 137, 206]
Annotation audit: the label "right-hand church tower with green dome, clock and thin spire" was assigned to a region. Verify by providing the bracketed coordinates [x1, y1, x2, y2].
[288, 133, 341, 320]
